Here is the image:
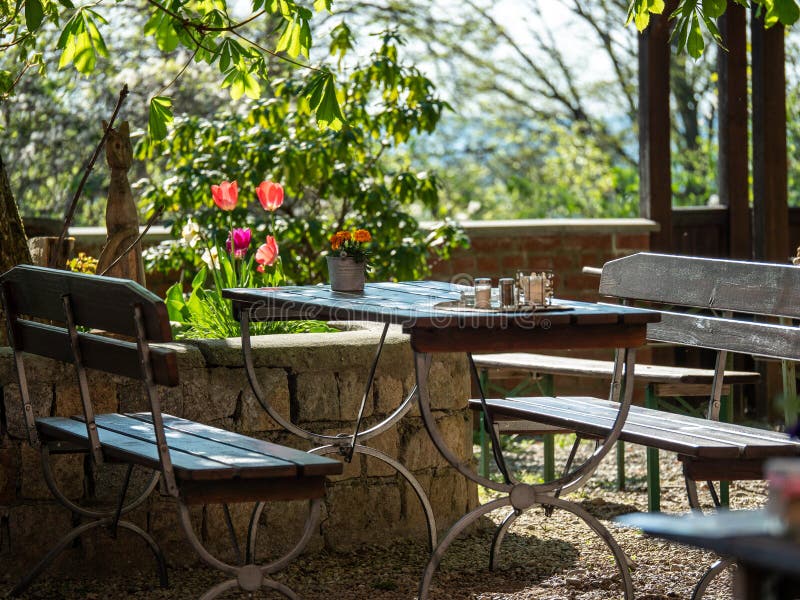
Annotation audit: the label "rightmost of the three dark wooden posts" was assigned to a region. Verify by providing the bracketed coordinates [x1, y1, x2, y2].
[750, 4, 791, 262]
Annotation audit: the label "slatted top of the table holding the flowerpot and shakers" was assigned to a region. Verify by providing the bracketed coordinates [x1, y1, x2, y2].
[223, 281, 659, 329]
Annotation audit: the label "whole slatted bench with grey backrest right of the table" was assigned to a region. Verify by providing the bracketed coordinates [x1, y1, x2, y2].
[472, 254, 800, 507]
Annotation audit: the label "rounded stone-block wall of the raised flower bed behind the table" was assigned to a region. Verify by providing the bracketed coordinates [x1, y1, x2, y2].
[0, 328, 477, 572]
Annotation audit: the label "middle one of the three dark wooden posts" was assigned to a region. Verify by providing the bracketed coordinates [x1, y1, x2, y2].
[717, 2, 753, 260]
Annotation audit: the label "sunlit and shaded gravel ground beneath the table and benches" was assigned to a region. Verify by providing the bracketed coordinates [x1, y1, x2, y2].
[0, 436, 766, 600]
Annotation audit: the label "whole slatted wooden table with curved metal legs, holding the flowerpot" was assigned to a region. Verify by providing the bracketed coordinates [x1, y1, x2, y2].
[223, 281, 659, 599]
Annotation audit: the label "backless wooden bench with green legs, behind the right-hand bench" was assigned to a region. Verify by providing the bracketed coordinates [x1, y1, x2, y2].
[474, 352, 760, 511]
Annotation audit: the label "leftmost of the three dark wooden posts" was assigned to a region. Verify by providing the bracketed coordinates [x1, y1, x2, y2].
[639, 1, 675, 252]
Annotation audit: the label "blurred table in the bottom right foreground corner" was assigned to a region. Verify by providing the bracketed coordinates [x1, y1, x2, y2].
[617, 510, 800, 600]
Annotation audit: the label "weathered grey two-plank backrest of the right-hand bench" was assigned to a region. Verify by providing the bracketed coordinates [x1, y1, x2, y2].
[600, 253, 800, 360]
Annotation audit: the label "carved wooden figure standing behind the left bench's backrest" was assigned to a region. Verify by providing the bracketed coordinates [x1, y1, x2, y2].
[97, 121, 145, 285]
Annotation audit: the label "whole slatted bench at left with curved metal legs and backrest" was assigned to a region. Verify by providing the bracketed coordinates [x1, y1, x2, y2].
[0, 266, 342, 598]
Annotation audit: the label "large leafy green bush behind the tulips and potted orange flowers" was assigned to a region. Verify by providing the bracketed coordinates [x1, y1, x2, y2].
[138, 25, 464, 283]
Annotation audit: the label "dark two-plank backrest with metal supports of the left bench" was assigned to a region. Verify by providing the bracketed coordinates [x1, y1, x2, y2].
[0, 265, 178, 493]
